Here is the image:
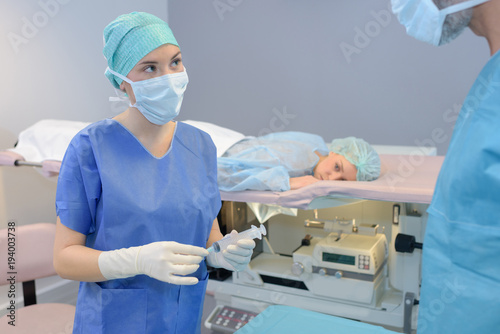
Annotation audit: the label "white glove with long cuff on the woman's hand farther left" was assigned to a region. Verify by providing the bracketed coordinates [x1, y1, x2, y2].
[98, 241, 208, 285]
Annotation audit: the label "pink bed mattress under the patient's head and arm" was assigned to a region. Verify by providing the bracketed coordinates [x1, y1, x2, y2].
[221, 155, 444, 209]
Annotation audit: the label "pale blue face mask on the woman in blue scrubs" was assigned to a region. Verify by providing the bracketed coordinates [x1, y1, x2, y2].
[106, 68, 189, 125]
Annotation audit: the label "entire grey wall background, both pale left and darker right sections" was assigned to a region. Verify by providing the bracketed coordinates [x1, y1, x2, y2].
[0, 0, 488, 154]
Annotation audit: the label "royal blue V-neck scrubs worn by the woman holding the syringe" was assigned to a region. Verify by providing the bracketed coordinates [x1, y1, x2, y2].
[54, 120, 221, 334]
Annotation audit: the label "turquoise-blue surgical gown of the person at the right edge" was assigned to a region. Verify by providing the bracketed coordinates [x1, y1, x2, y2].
[418, 52, 500, 334]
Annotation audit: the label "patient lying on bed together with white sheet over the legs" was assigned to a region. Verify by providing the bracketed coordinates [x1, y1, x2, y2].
[0, 120, 380, 191]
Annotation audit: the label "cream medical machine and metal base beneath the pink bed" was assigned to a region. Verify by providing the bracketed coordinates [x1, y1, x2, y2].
[207, 201, 426, 333]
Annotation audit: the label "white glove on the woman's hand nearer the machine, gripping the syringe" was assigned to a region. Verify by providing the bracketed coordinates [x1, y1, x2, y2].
[207, 230, 255, 271]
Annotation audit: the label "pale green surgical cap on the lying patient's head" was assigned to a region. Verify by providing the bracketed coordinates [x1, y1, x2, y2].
[328, 137, 380, 181]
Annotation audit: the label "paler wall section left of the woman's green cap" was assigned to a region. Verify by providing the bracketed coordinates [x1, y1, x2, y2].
[0, 0, 167, 148]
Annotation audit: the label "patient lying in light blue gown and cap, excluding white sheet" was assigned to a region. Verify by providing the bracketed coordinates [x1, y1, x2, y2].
[217, 132, 380, 191]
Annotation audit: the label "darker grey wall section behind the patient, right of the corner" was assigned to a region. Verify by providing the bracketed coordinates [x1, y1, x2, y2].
[169, 0, 489, 154]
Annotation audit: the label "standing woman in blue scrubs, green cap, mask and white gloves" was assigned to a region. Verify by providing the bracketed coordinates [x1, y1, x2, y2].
[53, 12, 255, 334]
